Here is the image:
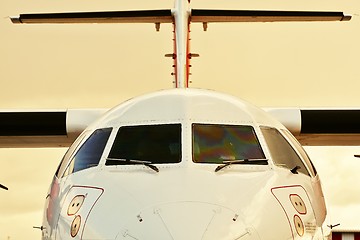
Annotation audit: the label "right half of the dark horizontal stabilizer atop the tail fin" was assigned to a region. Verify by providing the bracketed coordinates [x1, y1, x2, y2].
[191, 9, 351, 22]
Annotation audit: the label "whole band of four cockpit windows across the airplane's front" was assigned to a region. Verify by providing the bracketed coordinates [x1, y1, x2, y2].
[57, 123, 316, 177]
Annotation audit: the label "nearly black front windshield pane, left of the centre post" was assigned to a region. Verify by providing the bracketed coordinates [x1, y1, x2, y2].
[106, 124, 181, 165]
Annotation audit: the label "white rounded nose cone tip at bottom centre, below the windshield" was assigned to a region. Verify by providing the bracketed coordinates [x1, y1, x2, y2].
[116, 201, 259, 240]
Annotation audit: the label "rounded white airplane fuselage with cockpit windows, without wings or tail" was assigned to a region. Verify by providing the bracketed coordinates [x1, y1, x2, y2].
[42, 89, 326, 240]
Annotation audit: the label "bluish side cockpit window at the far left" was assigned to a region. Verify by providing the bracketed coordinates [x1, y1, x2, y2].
[64, 128, 112, 176]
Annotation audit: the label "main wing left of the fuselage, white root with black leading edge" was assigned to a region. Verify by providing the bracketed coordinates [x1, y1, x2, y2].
[0, 109, 106, 148]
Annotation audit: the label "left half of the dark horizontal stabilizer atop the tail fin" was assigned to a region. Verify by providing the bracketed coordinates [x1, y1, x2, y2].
[10, 9, 173, 23]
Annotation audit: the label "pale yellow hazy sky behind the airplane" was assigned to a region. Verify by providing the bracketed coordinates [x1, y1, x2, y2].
[0, 0, 360, 240]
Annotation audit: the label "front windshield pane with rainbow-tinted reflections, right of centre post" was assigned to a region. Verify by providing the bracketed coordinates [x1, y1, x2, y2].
[192, 124, 265, 164]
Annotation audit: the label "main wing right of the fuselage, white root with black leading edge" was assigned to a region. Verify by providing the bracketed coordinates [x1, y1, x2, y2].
[266, 108, 360, 146]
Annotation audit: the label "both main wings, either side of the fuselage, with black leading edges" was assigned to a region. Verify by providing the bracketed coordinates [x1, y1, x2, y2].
[0, 108, 360, 148]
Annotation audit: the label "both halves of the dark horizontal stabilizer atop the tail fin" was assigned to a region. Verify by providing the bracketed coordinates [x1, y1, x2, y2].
[10, 9, 351, 23]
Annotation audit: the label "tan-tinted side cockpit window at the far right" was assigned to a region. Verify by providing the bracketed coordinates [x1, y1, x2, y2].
[261, 127, 310, 176]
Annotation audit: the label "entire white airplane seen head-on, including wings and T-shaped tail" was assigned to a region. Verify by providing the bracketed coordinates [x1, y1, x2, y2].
[4, 0, 360, 240]
